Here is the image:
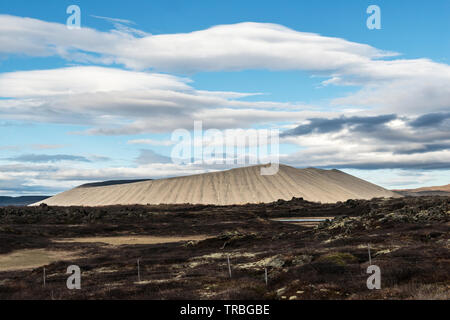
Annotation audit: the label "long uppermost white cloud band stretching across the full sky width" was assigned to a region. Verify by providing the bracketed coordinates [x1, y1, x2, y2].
[0, 15, 450, 114]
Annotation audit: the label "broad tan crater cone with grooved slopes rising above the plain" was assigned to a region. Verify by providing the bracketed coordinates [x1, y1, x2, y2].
[34, 165, 400, 206]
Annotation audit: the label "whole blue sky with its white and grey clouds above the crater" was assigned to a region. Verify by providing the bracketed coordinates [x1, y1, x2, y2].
[0, 0, 450, 195]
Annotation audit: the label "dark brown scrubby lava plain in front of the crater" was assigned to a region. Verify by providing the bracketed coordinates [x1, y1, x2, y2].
[0, 196, 450, 300]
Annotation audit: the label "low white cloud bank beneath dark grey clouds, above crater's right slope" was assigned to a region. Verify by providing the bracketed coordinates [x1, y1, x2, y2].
[280, 130, 450, 170]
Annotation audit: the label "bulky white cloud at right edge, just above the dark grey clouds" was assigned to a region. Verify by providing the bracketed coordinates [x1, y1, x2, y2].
[331, 59, 450, 115]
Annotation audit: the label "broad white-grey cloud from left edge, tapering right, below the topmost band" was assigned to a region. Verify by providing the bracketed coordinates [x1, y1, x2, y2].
[0, 66, 330, 135]
